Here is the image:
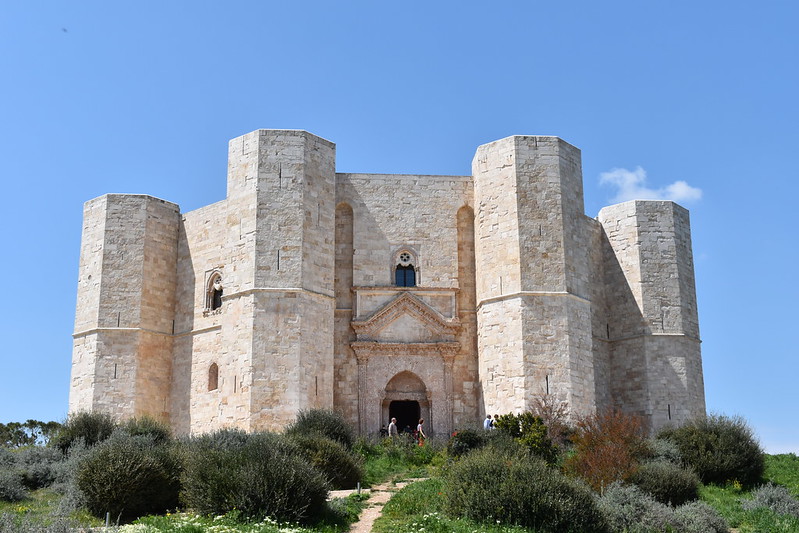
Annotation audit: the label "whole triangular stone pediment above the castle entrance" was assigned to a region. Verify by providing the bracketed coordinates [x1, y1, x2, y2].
[352, 292, 460, 342]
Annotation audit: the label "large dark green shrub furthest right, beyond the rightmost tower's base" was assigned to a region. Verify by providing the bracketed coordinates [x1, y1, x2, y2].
[658, 415, 765, 487]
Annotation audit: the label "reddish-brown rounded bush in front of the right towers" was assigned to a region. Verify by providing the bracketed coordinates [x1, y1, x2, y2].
[564, 411, 648, 492]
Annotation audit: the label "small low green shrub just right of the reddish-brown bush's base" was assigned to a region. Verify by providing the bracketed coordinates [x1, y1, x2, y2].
[630, 461, 699, 505]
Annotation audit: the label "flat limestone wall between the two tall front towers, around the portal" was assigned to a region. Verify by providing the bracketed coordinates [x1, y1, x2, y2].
[334, 174, 479, 433]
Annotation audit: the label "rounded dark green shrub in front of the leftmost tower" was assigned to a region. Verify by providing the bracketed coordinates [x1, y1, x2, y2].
[75, 432, 180, 521]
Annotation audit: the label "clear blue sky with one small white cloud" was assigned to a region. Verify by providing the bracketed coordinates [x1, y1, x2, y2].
[0, 0, 799, 452]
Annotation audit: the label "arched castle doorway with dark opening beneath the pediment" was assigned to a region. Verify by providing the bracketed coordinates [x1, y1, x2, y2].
[381, 371, 433, 432]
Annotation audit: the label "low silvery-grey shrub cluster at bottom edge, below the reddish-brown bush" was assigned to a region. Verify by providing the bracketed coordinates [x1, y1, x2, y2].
[598, 482, 728, 533]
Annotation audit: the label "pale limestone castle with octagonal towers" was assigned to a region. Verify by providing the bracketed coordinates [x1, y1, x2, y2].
[69, 130, 705, 435]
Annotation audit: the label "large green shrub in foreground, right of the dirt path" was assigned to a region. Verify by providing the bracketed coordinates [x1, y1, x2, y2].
[445, 447, 606, 532]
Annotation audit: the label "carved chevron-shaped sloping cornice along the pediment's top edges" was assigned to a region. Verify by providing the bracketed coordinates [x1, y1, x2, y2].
[352, 292, 461, 340]
